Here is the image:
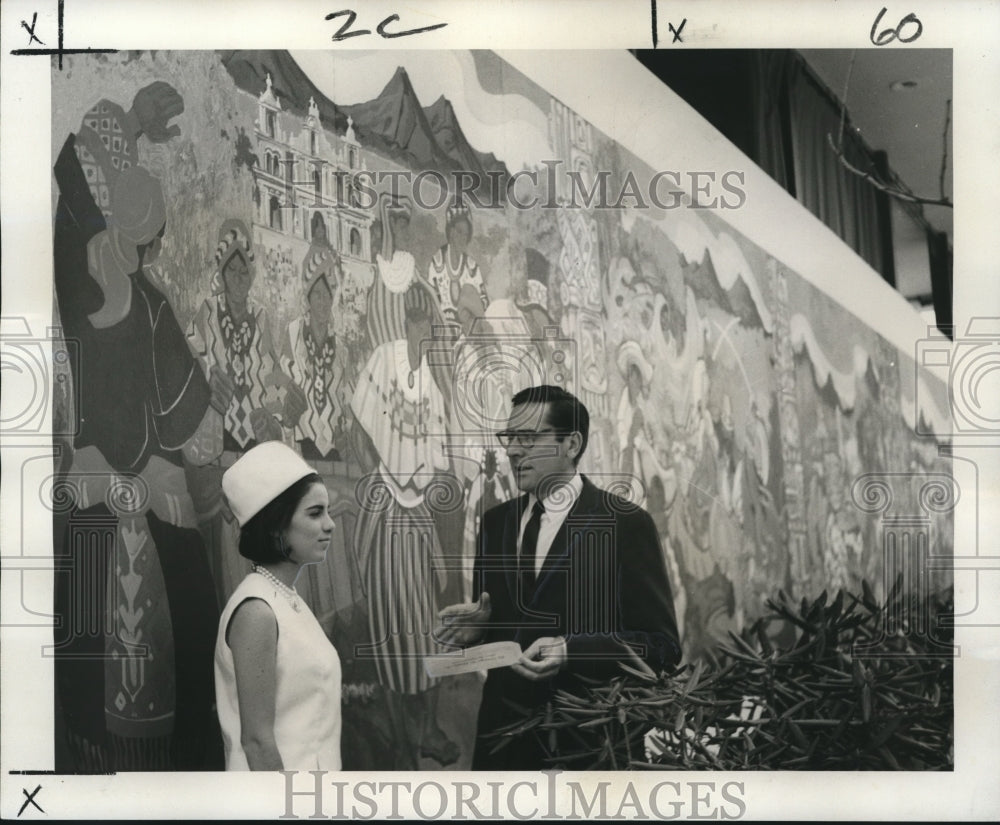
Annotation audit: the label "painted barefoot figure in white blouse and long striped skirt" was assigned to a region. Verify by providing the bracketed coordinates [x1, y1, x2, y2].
[351, 283, 459, 769]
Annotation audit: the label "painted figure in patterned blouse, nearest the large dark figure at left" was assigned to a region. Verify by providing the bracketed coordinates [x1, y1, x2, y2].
[186, 219, 306, 603]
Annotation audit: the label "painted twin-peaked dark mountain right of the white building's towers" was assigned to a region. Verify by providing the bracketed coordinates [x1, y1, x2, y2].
[344, 66, 508, 196]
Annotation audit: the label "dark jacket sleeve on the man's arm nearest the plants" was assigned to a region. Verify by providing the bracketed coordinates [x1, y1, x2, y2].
[566, 502, 681, 678]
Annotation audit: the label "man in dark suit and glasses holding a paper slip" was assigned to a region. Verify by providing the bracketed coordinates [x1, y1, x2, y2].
[437, 386, 681, 770]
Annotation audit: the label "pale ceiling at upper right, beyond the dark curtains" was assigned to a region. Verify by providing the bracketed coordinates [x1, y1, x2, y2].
[799, 47, 954, 243]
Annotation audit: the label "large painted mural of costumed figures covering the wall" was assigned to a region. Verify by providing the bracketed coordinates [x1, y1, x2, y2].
[52, 52, 951, 771]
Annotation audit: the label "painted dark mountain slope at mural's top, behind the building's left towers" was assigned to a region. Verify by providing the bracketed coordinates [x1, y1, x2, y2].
[219, 49, 347, 135]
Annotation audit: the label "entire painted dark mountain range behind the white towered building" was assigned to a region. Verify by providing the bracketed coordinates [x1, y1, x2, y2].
[220, 50, 509, 191]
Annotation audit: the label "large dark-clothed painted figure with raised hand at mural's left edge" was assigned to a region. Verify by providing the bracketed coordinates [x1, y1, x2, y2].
[54, 82, 221, 772]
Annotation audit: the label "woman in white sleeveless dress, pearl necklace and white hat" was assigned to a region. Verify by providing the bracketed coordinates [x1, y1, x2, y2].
[215, 441, 341, 771]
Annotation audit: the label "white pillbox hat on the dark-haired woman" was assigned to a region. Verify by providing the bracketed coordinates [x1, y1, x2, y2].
[222, 441, 316, 527]
